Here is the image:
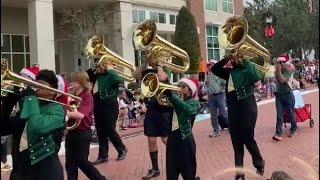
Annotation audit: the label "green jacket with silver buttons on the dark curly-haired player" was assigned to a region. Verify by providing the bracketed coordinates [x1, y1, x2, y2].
[20, 96, 65, 165]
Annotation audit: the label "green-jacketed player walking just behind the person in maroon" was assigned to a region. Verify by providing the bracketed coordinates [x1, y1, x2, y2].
[87, 59, 128, 164]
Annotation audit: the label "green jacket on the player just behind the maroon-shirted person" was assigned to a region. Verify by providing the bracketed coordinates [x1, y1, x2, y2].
[96, 69, 123, 100]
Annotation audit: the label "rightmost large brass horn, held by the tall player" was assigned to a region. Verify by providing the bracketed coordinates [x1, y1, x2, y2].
[219, 16, 271, 73]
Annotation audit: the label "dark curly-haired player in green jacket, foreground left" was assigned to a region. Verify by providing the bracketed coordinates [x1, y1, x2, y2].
[2, 70, 65, 180]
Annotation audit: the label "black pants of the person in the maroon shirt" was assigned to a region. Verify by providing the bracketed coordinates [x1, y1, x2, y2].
[65, 129, 105, 180]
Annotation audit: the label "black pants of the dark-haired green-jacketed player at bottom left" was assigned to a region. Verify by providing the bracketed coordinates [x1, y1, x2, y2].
[30, 153, 64, 180]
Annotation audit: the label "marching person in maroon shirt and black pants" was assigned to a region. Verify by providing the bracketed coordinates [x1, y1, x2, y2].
[65, 71, 106, 180]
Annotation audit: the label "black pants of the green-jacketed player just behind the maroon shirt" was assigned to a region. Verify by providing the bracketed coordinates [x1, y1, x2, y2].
[94, 97, 126, 158]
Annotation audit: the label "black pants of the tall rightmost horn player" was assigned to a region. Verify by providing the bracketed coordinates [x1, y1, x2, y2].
[227, 95, 262, 168]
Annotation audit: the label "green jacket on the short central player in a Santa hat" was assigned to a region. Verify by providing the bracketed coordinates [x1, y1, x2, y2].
[169, 94, 200, 140]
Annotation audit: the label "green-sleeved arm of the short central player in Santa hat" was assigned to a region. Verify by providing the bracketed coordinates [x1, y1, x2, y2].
[166, 93, 200, 115]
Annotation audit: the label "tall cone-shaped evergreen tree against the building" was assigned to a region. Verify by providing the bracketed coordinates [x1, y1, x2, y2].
[174, 6, 200, 74]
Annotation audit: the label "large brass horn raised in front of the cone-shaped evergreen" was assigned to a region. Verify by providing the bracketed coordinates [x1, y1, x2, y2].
[133, 20, 190, 73]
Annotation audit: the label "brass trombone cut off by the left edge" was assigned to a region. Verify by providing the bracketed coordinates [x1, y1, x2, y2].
[1, 58, 82, 130]
